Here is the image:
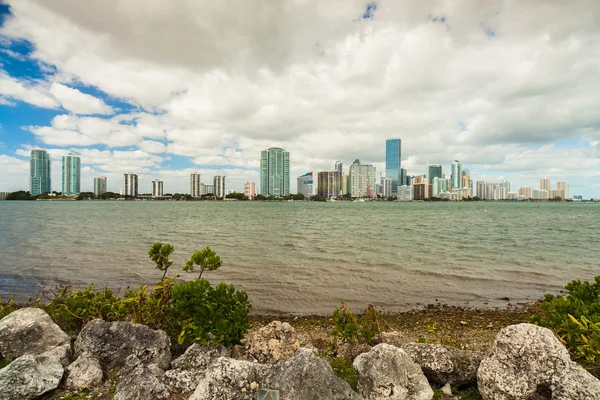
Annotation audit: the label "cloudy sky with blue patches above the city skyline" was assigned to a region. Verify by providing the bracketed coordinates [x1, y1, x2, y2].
[0, 0, 600, 197]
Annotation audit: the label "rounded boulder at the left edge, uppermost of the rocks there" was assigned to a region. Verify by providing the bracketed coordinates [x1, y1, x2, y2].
[0, 308, 71, 361]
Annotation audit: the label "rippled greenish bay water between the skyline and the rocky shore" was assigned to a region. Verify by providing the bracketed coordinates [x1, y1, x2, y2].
[0, 201, 600, 313]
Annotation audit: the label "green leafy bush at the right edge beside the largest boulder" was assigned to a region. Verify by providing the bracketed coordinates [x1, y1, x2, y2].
[532, 276, 600, 372]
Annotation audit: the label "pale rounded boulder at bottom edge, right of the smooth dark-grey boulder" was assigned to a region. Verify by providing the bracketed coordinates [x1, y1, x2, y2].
[353, 343, 433, 400]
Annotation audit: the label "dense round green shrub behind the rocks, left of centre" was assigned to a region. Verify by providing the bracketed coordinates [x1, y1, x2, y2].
[171, 279, 251, 347]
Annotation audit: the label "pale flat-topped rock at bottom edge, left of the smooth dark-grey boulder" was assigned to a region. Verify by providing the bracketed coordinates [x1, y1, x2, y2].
[189, 357, 270, 400]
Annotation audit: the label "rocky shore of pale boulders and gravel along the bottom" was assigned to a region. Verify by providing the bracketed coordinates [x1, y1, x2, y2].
[0, 305, 600, 400]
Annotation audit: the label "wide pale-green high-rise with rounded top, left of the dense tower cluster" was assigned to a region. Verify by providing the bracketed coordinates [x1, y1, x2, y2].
[260, 147, 290, 197]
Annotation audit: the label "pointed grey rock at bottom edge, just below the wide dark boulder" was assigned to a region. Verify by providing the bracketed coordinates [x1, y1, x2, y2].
[113, 354, 171, 400]
